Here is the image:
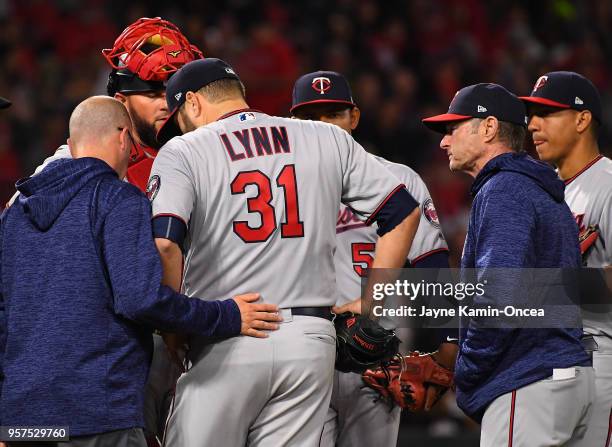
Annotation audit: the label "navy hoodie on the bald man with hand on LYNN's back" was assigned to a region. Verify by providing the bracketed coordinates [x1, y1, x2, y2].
[0, 158, 240, 436]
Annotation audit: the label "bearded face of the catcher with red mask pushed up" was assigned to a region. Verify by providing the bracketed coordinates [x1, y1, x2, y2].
[124, 90, 168, 149]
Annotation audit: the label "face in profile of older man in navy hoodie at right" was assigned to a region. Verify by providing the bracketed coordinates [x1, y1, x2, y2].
[440, 119, 483, 175]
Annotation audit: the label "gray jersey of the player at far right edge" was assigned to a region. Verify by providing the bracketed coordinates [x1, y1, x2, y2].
[565, 156, 612, 337]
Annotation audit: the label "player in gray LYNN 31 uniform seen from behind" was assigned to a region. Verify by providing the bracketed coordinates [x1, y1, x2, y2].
[148, 58, 419, 446]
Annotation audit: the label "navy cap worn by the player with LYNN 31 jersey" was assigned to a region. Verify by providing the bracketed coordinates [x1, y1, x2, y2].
[157, 57, 240, 144]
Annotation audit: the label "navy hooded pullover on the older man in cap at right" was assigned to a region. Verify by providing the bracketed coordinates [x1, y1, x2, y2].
[455, 153, 591, 421]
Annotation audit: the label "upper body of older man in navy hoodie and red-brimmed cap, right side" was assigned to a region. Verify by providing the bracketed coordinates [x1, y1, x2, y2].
[423, 84, 591, 434]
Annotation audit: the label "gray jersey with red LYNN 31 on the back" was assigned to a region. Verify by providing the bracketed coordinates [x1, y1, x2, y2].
[148, 111, 403, 307]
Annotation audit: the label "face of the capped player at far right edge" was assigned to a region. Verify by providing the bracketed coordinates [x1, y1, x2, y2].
[528, 105, 579, 164]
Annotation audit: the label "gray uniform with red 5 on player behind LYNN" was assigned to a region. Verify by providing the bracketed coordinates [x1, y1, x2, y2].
[320, 157, 448, 447]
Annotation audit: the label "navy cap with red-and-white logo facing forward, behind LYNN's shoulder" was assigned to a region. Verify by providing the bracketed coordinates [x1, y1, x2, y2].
[290, 71, 355, 113]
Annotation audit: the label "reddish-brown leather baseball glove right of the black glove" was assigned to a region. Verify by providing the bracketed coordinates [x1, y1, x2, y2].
[362, 351, 454, 412]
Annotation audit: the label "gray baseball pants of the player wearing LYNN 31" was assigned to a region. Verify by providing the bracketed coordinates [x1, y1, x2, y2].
[164, 312, 336, 447]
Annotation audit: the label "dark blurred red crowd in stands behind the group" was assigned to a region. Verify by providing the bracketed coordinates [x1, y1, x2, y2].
[0, 0, 612, 447]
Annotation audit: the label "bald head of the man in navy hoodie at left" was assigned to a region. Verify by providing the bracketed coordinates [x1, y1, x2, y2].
[69, 96, 130, 149]
